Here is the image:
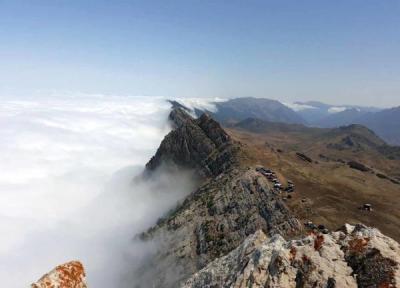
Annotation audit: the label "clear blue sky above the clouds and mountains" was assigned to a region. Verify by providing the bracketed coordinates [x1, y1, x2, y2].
[0, 0, 400, 106]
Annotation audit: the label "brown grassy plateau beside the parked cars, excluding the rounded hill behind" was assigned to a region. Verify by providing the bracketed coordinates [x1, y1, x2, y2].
[227, 129, 400, 241]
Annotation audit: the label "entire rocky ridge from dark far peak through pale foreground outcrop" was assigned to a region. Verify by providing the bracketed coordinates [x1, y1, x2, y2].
[32, 107, 400, 288]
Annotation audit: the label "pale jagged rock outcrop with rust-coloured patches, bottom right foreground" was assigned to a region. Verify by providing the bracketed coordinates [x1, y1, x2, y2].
[183, 225, 400, 288]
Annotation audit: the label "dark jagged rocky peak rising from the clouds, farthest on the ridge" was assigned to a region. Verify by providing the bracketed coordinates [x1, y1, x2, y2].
[146, 108, 238, 176]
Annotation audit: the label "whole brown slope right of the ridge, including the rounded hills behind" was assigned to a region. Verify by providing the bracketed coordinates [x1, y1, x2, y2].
[227, 123, 400, 240]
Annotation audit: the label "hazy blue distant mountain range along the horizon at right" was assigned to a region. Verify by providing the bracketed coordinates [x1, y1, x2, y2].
[188, 97, 400, 145]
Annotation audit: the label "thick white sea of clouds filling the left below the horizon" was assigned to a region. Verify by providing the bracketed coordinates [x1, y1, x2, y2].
[0, 95, 216, 288]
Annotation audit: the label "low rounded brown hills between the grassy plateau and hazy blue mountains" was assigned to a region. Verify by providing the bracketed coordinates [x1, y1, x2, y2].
[233, 119, 400, 170]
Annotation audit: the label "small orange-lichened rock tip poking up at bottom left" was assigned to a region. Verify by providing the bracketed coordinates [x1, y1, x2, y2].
[31, 261, 87, 288]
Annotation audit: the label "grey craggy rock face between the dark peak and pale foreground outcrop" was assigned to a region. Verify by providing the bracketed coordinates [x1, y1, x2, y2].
[139, 168, 302, 287]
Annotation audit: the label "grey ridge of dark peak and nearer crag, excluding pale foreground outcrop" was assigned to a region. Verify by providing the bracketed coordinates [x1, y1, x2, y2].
[140, 108, 301, 287]
